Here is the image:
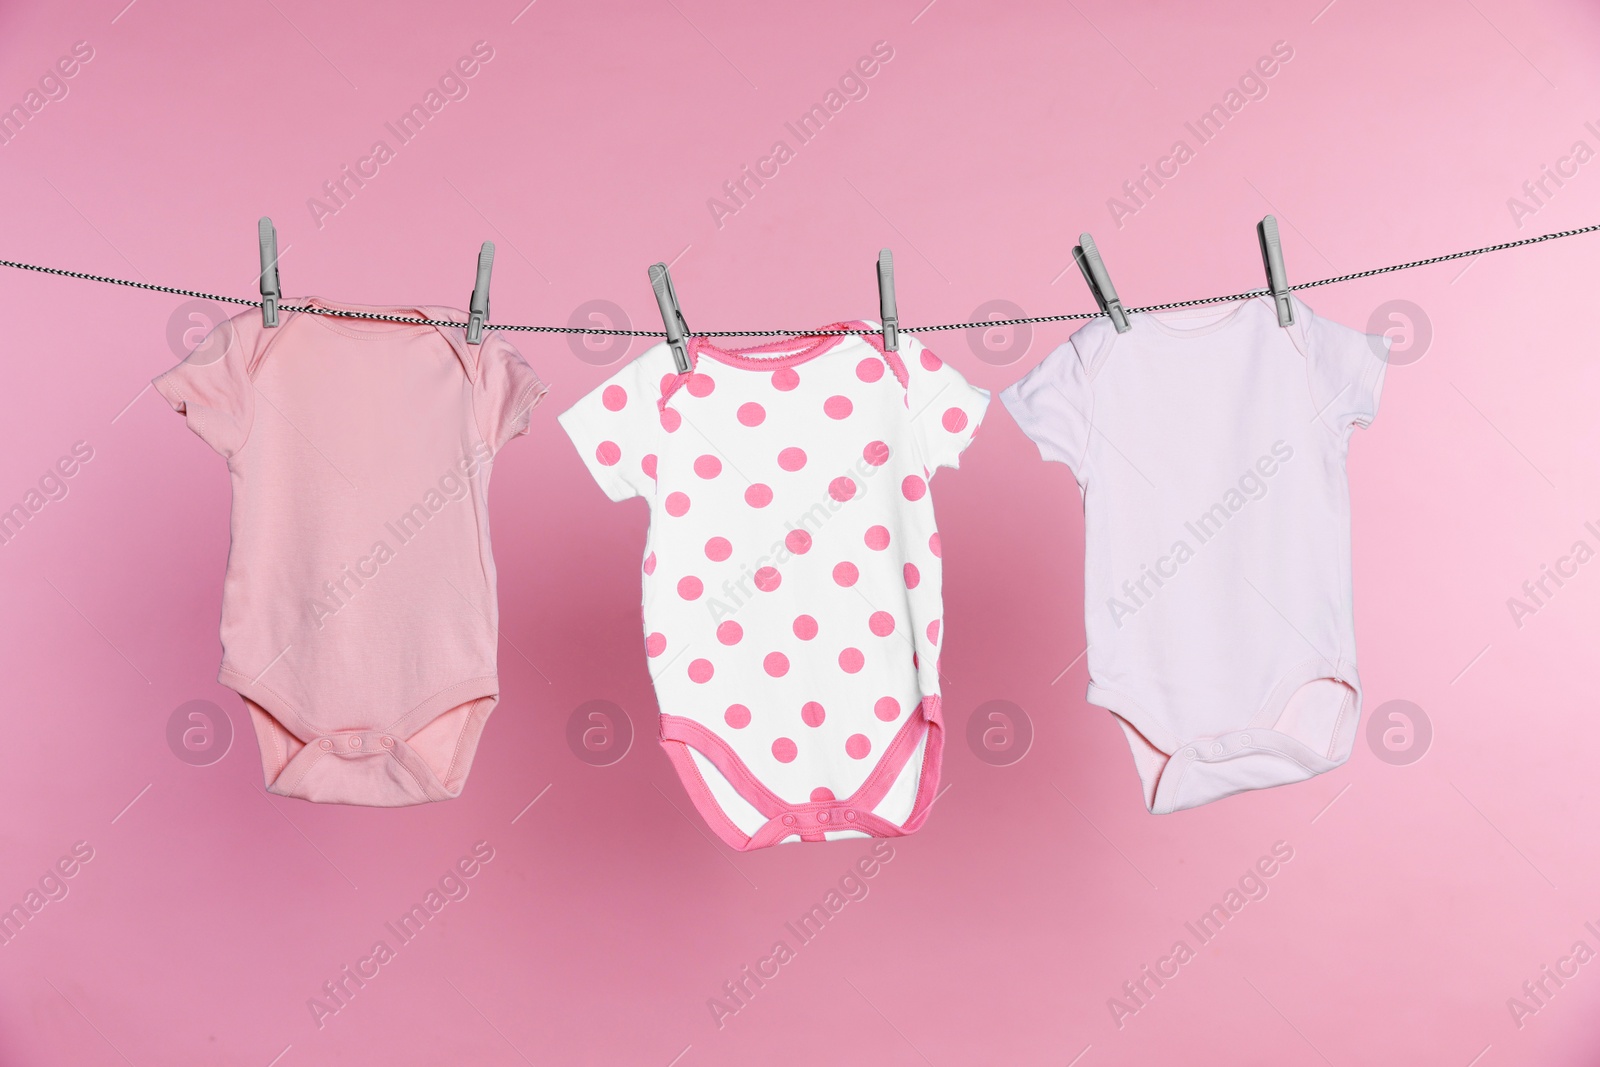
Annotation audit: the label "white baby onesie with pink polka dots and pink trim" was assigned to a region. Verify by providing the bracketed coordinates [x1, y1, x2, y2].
[560, 323, 989, 851]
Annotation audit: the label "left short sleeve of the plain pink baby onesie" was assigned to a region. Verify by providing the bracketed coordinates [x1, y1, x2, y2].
[150, 310, 262, 458]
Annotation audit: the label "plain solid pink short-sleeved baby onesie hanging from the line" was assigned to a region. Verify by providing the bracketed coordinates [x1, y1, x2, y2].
[155, 298, 544, 806]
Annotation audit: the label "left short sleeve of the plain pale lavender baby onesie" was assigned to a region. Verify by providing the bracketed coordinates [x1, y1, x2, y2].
[1000, 320, 1106, 480]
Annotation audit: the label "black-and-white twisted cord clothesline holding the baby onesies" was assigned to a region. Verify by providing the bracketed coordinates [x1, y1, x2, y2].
[0, 222, 1600, 338]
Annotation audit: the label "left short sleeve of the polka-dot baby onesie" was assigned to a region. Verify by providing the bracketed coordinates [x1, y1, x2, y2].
[558, 344, 672, 501]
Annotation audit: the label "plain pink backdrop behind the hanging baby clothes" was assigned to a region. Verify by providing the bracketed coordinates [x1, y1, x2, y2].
[0, 0, 1600, 1067]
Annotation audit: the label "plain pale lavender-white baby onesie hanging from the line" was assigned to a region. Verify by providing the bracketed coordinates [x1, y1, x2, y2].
[1002, 298, 1389, 814]
